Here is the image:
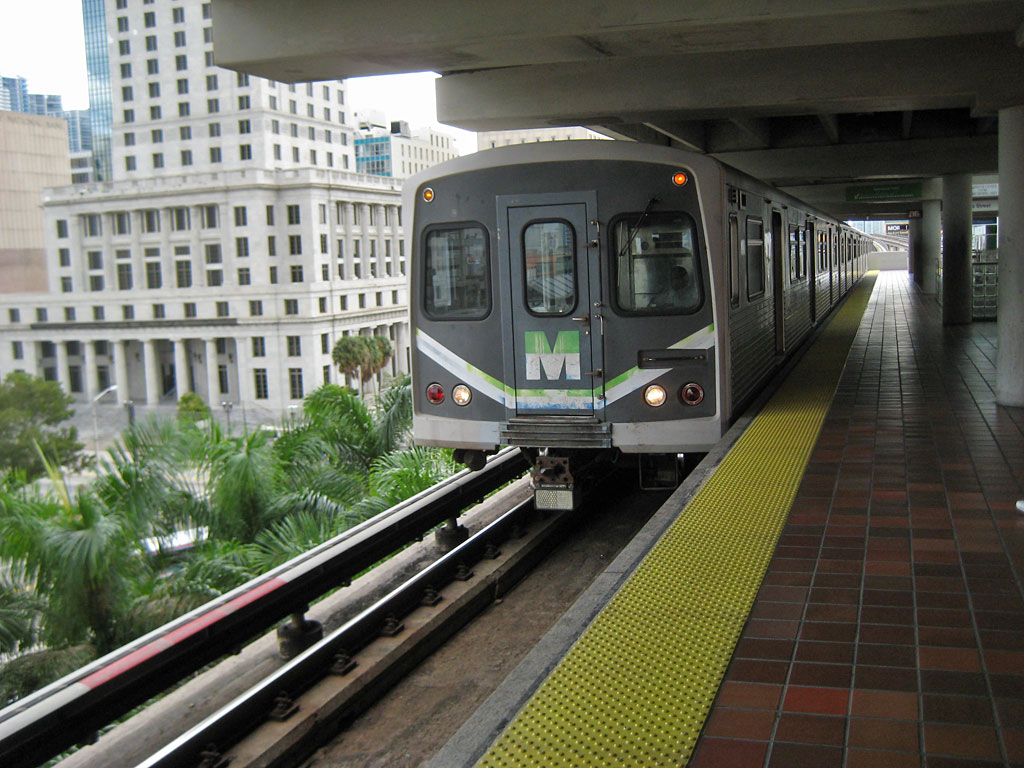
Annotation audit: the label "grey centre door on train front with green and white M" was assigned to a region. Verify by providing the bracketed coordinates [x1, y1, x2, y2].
[496, 193, 603, 417]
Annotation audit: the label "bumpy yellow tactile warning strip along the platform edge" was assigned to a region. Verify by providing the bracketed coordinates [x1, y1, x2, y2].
[478, 273, 874, 768]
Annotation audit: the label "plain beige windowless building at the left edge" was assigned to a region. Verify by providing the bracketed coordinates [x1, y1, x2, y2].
[0, 112, 71, 293]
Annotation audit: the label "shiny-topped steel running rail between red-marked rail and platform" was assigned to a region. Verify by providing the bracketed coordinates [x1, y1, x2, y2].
[136, 500, 534, 768]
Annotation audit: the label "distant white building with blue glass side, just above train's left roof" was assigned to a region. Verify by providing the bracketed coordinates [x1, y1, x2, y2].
[355, 121, 459, 178]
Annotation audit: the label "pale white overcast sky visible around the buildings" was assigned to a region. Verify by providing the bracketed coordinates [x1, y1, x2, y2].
[0, 0, 476, 155]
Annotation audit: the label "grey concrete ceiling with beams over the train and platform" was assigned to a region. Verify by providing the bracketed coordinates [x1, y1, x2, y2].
[213, 0, 1024, 217]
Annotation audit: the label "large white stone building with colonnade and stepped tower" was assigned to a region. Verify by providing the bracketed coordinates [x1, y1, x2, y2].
[0, 0, 438, 418]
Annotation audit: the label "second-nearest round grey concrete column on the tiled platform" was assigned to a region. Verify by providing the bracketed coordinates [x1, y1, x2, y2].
[942, 173, 973, 326]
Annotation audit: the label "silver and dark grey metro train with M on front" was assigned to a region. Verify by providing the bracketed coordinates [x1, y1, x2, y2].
[403, 140, 868, 509]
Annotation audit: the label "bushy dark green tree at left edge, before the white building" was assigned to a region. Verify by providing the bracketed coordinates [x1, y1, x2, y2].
[0, 371, 82, 479]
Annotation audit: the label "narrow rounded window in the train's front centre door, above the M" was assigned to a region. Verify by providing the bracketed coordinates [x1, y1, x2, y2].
[522, 221, 577, 315]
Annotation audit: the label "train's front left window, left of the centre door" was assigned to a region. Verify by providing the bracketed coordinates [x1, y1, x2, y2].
[423, 224, 490, 319]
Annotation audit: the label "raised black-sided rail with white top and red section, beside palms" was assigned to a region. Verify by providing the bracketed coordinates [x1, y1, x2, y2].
[0, 449, 526, 768]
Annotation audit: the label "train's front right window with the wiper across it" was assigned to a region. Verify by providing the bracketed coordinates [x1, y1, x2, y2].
[611, 212, 703, 314]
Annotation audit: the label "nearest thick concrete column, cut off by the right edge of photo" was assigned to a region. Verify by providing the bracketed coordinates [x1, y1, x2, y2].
[995, 105, 1024, 408]
